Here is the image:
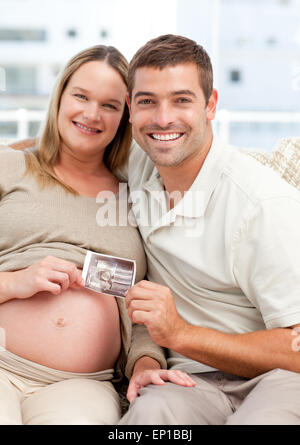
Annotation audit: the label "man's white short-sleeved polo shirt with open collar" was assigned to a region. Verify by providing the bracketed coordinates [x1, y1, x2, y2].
[124, 138, 300, 372]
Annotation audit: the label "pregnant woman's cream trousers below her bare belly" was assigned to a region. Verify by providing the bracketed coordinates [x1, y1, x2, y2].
[0, 349, 120, 425]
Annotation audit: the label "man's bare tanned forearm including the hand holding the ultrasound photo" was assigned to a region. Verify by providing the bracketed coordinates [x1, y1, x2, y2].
[126, 281, 300, 378]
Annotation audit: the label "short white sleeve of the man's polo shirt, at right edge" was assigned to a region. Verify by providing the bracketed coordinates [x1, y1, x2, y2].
[234, 196, 300, 329]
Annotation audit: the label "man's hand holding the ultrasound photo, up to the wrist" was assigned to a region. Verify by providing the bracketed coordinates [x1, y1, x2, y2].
[125, 280, 186, 349]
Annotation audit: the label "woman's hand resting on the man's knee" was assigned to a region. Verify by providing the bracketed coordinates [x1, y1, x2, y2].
[127, 356, 195, 403]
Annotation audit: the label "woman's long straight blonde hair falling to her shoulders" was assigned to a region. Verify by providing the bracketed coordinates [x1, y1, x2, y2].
[26, 45, 132, 194]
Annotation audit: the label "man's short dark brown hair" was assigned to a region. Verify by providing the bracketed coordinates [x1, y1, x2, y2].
[128, 34, 213, 104]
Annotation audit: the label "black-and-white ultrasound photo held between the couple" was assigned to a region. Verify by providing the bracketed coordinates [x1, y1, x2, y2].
[82, 251, 136, 297]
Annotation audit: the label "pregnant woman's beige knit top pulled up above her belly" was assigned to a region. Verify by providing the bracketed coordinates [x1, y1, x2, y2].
[0, 146, 165, 377]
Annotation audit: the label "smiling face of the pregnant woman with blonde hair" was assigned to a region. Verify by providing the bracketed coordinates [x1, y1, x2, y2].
[58, 61, 127, 157]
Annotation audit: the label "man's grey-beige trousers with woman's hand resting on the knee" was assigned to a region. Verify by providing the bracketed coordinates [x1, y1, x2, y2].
[119, 369, 300, 425]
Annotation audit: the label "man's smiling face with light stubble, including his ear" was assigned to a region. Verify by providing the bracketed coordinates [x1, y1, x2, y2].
[130, 63, 217, 167]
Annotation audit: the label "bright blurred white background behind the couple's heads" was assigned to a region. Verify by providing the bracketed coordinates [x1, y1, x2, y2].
[0, 0, 300, 151]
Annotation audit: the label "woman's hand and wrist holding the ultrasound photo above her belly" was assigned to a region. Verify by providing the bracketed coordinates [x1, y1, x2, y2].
[1, 256, 84, 301]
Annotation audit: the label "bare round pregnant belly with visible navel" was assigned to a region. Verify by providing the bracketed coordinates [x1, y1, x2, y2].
[0, 288, 121, 372]
